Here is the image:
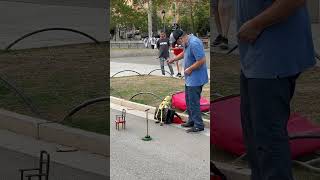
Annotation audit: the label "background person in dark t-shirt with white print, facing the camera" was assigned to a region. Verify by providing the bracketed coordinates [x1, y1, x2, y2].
[157, 32, 174, 75]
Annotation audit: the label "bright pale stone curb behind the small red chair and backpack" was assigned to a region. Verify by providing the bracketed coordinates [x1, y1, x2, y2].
[110, 96, 210, 128]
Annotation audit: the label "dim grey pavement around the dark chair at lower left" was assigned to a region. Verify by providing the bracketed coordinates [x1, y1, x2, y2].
[0, 130, 109, 180]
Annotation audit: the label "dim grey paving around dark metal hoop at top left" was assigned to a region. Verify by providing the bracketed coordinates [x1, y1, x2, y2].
[0, 0, 108, 49]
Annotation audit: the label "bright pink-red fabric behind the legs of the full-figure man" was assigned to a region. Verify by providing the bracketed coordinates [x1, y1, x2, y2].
[172, 92, 210, 112]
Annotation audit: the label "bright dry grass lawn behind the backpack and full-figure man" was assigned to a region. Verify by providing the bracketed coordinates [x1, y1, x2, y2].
[110, 75, 210, 107]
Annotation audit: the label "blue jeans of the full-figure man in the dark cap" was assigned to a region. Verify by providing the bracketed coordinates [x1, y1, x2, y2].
[185, 86, 204, 129]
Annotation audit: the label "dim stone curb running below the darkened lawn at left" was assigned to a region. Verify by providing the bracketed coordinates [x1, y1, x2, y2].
[0, 109, 110, 156]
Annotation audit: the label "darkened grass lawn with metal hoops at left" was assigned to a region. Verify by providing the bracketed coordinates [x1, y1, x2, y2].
[0, 43, 109, 134]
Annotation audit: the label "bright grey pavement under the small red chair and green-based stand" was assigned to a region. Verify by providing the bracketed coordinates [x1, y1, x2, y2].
[110, 106, 210, 180]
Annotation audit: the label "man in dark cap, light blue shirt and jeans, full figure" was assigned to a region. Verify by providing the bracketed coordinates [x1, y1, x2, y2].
[168, 29, 208, 132]
